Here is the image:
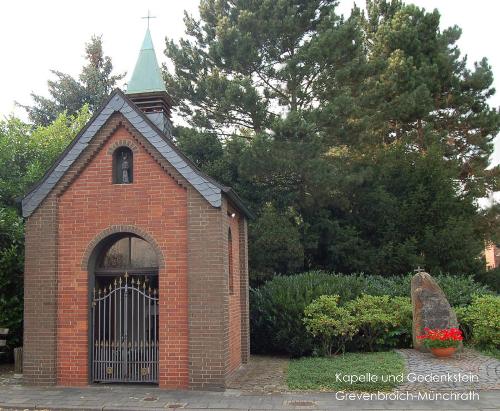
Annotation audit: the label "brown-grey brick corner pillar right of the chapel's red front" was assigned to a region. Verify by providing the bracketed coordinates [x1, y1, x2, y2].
[188, 189, 229, 389]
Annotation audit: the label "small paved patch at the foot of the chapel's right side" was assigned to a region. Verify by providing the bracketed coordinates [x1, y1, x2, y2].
[228, 355, 288, 394]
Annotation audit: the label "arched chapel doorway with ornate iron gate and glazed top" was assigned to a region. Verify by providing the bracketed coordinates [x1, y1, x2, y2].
[89, 233, 159, 383]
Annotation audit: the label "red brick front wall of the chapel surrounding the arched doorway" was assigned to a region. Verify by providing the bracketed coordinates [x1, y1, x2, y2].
[57, 127, 188, 388]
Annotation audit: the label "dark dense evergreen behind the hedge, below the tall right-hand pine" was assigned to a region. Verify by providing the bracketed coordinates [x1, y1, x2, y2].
[310, 143, 484, 275]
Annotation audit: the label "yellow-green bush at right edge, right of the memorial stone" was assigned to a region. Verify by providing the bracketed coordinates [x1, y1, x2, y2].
[459, 295, 500, 349]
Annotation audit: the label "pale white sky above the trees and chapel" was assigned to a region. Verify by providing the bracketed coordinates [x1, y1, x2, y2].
[0, 0, 500, 164]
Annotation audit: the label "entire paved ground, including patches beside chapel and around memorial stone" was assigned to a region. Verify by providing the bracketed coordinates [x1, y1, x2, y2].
[0, 350, 500, 411]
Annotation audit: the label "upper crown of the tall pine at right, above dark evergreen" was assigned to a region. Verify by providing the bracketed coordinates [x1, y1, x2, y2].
[316, 0, 500, 198]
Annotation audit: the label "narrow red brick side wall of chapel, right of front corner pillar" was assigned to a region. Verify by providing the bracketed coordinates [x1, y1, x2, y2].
[226, 207, 241, 372]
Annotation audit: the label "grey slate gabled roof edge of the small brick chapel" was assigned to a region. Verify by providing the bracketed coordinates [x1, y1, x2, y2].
[22, 89, 251, 217]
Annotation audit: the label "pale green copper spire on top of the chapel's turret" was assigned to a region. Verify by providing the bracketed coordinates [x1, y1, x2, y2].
[126, 28, 166, 94]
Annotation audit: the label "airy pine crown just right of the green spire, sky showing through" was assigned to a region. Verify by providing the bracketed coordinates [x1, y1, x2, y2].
[165, 0, 335, 138]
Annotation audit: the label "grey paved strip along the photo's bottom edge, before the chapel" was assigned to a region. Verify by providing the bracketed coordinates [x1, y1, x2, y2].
[0, 386, 500, 411]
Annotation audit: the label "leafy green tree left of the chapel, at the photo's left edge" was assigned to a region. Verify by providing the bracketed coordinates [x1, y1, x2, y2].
[0, 106, 90, 354]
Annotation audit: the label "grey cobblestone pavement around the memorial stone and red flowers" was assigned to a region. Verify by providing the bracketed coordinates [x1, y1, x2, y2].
[396, 349, 500, 391]
